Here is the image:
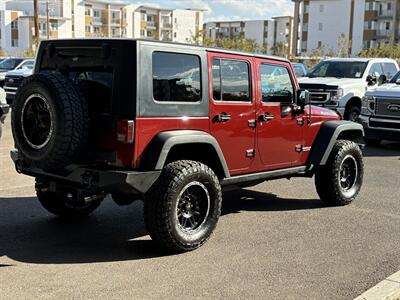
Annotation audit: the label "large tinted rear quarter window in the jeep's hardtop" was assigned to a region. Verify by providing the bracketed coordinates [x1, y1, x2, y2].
[153, 52, 201, 102]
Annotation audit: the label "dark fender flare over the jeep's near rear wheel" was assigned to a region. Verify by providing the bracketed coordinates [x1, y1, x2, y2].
[144, 130, 230, 179]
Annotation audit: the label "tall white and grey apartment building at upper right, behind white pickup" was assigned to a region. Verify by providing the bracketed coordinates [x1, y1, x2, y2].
[292, 0, 400, 55]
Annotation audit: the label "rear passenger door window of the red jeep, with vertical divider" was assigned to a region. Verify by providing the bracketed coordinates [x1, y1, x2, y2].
[212, 59, 251, 102]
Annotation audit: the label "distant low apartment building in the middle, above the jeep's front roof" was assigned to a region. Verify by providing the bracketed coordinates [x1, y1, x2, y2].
[203, 16, 293, 54]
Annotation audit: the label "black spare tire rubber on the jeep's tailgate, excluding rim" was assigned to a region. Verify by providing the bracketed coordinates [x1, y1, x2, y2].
[11, 73, 89, 170]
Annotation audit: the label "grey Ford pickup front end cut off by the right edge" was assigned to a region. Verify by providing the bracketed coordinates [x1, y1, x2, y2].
[359, 72, 400, 145]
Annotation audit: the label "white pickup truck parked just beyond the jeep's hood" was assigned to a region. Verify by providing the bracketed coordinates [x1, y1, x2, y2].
[299, 58, 399, 121]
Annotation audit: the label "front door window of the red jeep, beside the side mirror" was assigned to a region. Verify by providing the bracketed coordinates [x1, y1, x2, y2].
[260, 64, 294, 102]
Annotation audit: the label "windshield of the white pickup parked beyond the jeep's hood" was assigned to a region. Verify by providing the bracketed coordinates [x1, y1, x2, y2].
[308, 61, 368, 78]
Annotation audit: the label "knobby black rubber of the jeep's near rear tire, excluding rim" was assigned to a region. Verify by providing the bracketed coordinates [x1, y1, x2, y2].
[144, 160, 222, 253]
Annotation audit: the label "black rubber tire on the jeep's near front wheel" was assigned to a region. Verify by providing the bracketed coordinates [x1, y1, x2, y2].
[315, 140, 364, 206]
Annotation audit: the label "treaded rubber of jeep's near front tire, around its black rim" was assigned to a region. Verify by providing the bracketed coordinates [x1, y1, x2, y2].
[315, 140, 364, 206]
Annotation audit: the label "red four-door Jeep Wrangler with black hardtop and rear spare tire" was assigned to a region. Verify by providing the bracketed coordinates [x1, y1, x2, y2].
[11, 39, 363, 252]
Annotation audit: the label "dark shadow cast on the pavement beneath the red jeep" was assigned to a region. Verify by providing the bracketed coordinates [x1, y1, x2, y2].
[0, 190, 323, 267]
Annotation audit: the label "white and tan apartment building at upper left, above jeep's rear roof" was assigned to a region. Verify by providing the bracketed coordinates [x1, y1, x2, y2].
[0, 0, 203, 54]
